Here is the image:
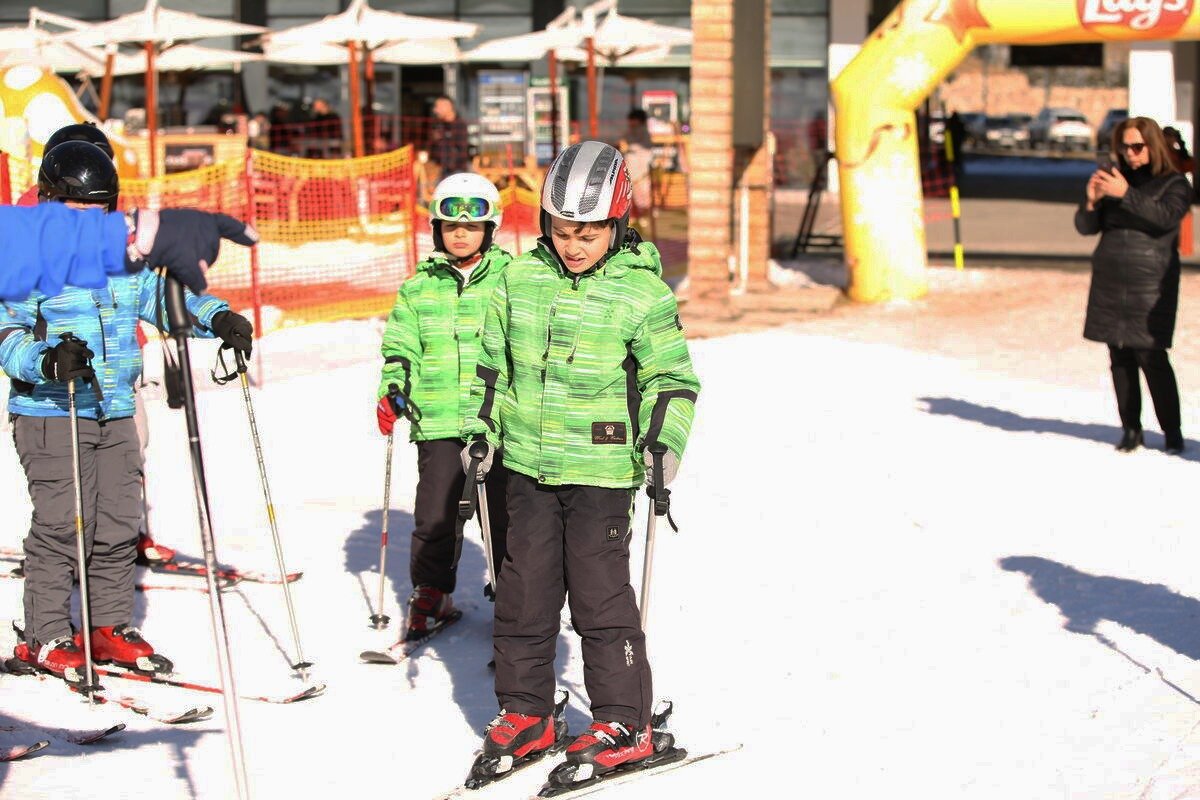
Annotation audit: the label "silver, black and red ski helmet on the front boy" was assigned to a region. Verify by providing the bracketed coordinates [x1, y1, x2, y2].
[541, 142, 634, 249]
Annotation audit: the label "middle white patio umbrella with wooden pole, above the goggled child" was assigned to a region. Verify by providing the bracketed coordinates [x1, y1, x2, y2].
[265, 0, 479, 156]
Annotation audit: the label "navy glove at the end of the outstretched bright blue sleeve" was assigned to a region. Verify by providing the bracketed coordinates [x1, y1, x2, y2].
[125, 209, 258, 294]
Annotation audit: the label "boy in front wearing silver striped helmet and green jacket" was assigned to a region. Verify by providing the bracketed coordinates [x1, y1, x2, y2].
[462, 142, 700, 786]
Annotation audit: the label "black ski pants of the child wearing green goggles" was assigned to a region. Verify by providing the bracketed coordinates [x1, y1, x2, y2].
[408, 439, 509, 594]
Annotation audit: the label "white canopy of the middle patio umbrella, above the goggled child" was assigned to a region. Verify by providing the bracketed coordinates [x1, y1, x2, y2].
[266, 0, 479, 48]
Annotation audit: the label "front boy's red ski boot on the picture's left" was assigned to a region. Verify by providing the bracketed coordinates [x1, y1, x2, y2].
[464, 691, 566, 789]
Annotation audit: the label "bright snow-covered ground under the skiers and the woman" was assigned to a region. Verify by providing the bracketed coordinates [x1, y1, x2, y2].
[0, 273, 1200, 800]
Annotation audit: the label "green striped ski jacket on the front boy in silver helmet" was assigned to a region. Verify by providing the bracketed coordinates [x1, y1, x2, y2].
[463, 240, 700, 488]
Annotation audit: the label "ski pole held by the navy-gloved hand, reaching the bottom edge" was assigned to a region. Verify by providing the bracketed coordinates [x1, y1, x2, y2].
[166, 277, 250, 800]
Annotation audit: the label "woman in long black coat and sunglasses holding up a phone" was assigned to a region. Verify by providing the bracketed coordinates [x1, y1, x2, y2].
[1075, 116, 1192, 456]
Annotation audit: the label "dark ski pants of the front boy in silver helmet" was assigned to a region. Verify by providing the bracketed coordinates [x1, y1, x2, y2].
[494, 473, 652, 728]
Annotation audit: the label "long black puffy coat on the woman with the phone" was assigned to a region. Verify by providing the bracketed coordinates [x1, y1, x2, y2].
[1075, 170, 1192, 350]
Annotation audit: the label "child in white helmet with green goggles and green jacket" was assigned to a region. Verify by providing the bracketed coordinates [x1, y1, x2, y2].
[376, 173, 511, 639]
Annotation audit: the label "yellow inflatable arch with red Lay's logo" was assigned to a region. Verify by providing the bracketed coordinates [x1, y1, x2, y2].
[832, 0, 1200, 302]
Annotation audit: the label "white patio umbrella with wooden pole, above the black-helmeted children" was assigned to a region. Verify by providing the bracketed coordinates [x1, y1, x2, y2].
[64, 0, 266, 175]
